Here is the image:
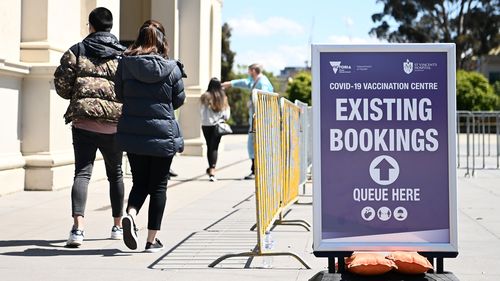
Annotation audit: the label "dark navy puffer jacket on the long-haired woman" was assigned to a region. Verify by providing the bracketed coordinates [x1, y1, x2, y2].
[115, 55, 186, 157]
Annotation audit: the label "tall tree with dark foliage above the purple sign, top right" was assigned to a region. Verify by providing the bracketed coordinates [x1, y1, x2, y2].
[370, 0, 500, 68]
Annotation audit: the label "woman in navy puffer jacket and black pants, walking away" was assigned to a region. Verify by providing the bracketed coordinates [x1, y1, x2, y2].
[115, 20, 186, 252]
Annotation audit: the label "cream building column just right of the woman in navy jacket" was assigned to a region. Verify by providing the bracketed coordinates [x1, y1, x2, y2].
[178, 0, 222, 155]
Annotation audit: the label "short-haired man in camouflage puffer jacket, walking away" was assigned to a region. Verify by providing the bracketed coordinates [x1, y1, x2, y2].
[54, 7, 125, 247]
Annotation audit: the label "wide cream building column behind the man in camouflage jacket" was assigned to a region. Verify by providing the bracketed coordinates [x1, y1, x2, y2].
[20, 0, 114, 190]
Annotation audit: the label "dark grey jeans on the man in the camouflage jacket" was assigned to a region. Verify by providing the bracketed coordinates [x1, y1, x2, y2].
[71, 128, 124, 218]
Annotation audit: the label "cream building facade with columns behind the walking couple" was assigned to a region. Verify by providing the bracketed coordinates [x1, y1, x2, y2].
[0, 0, 222, 196]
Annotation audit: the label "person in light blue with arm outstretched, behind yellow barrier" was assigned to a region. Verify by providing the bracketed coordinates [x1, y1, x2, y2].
[222, 63, 274, 179]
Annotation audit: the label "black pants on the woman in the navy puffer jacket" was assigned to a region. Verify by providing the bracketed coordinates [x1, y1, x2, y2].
[127, 153, 174, 230]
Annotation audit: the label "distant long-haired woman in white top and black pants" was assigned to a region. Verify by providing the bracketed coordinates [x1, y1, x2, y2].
[200, 78, 231, 181]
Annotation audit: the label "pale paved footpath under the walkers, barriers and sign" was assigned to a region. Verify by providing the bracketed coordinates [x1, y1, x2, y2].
[0, 135, 500, 281]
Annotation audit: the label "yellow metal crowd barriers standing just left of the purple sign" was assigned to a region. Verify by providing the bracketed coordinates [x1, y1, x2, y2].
[209, 90, 310, 269]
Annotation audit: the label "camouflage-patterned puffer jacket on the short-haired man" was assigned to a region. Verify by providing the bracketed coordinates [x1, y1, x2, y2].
[54, 31, 125, 124]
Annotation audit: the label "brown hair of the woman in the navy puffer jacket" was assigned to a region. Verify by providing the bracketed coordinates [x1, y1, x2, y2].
[123, 20, 168, 59]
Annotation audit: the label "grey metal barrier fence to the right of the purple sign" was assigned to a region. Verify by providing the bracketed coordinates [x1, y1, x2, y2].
[457, 111, 500, 176]
